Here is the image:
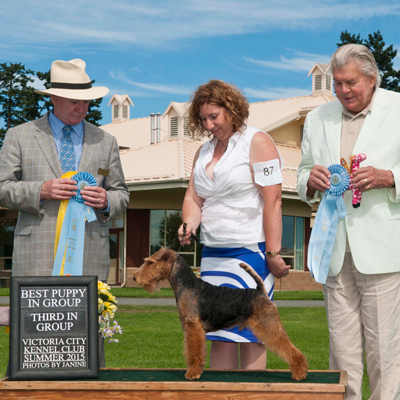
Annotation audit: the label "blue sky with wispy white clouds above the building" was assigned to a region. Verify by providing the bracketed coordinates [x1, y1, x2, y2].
[0, 0, 400, 124]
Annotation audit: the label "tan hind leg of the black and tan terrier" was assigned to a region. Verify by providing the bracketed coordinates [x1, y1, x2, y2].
[248, 300, 308, 381]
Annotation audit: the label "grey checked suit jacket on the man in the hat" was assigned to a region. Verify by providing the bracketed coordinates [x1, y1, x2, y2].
[0, 115, 129, 280]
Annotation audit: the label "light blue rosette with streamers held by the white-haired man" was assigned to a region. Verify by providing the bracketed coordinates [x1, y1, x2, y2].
[307, 164, 350, 283]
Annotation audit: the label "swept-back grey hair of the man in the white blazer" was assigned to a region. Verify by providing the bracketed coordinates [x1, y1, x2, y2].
[330, 44, 382, 89]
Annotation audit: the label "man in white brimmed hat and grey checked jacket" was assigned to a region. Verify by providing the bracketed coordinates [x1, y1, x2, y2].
[0, 60, 129, 281]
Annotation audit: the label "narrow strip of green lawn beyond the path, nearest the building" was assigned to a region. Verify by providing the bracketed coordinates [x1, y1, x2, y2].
[0, 288, 324, 300]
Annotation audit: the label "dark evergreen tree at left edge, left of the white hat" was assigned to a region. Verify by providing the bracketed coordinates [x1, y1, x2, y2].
[0, 62, 41, 148]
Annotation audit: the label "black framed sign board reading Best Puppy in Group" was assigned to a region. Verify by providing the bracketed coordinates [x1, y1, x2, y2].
[9, 276, 99, 380]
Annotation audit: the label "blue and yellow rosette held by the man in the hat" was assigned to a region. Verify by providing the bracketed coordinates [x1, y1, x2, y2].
[52, 172, 97, 276]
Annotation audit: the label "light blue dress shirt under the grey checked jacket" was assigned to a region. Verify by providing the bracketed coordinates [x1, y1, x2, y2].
[49, 111, 110, 213]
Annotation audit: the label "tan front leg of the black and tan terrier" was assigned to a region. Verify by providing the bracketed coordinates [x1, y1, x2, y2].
[182, 318, 207, 380]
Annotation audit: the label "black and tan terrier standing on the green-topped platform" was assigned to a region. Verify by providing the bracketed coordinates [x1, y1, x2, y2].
[133, 248, 308, 381]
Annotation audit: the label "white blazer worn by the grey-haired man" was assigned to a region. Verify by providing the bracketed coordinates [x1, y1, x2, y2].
[297, 89, 400, 276]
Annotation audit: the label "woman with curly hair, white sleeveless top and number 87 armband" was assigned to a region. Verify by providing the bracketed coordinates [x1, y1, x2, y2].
[178, 80, 289, 369]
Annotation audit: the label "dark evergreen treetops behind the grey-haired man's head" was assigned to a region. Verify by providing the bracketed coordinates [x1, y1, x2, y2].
[337, 30, 400, 92]
